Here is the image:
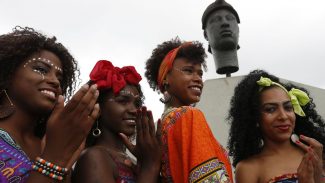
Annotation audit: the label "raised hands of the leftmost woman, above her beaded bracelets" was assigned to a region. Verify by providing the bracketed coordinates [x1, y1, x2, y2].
[42, 84, 99, 167]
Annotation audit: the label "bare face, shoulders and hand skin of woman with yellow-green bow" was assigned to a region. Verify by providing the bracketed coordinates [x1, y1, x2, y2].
[235, 87, 323, 183]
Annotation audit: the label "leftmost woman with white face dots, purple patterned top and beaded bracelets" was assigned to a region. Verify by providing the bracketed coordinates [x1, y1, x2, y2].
[0, 27, 99, 183]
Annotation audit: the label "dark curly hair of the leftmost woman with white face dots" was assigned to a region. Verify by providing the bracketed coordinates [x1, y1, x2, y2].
[0, 26, 79, 99]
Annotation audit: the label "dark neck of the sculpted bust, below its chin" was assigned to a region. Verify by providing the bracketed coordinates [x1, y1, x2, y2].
[211, 49, 238, 74]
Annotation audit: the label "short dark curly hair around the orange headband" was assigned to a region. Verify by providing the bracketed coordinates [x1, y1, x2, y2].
[145, 37, 207, 91]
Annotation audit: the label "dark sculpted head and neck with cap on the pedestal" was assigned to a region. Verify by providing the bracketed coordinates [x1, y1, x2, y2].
[202, 0, 240, 76]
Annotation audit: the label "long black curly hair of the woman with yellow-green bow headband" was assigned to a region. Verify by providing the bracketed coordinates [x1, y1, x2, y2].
[227, 70, 325, 166]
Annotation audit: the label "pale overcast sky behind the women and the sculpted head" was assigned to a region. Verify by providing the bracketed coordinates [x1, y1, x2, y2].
[0, 0, 325, 119]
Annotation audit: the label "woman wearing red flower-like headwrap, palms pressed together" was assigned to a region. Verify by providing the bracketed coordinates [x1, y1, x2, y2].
[72, 60, 160, 183]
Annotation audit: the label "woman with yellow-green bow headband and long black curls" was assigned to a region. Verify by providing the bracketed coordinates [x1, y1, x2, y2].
[229, 70, 325, 183]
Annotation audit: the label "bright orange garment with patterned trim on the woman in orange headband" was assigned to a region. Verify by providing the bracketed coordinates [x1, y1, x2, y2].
[161, 106, 233, 183]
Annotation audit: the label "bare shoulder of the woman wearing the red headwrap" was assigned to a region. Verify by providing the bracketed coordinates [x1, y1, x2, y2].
[72, 147, 115, 183]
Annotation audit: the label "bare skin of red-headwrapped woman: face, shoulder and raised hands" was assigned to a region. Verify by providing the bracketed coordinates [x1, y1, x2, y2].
[72, 85, 161, 183]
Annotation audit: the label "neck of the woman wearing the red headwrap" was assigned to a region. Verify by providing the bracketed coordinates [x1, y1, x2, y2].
[95, 126, 126, 152]
